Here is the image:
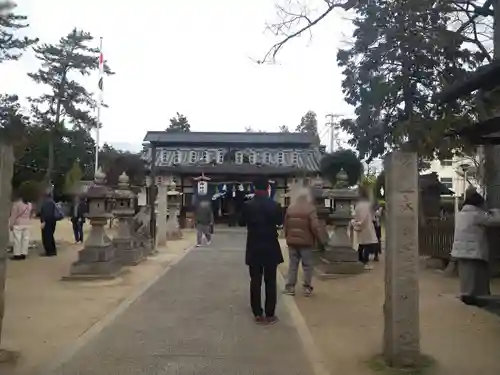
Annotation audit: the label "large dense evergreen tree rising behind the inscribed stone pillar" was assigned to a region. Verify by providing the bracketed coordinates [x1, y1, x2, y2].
[337, 0, 486, 159]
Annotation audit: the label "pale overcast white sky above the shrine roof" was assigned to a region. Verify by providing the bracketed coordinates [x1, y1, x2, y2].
[0, 0, 358, 153]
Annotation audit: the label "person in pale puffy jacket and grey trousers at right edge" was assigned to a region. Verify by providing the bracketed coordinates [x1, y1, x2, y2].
[451, 189, 500, 305]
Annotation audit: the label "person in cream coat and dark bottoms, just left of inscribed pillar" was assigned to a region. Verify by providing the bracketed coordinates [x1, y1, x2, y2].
[351, 188, 378, 270]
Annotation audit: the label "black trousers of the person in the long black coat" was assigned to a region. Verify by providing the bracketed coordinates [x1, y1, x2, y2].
[249, 265, 278, 317]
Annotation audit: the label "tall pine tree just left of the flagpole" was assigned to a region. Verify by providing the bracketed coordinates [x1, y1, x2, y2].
[28, 29, 114, 180]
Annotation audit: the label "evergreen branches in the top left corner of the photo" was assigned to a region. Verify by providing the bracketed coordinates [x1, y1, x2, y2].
[0, 0, 38, 63]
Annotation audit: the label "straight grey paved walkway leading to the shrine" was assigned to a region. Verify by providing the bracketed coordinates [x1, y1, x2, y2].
[47, 231, 313, 375]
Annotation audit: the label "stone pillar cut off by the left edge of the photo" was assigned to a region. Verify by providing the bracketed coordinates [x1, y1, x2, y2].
[0, 143, 14, 342]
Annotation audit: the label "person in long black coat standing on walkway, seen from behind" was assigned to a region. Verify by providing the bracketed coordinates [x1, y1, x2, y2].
[240, 179, 283, 324]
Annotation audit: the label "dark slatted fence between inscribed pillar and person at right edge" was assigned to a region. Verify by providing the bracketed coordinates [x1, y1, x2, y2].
[418, 216, 455, 259]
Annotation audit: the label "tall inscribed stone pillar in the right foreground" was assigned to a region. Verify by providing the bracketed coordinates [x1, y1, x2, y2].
[384, 152, 420, 367]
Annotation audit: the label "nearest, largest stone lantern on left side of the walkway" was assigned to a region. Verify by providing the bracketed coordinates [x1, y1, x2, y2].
[64, 168, 121, 280]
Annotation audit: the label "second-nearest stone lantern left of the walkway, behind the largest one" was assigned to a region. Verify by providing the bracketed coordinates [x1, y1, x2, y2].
[113, 172, 143, 266]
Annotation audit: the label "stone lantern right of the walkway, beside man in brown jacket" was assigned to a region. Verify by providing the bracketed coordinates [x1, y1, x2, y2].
[318, 170, 364, 275]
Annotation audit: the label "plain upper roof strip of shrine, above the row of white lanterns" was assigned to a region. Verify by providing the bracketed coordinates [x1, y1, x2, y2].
[144, 131, 316, 146]
